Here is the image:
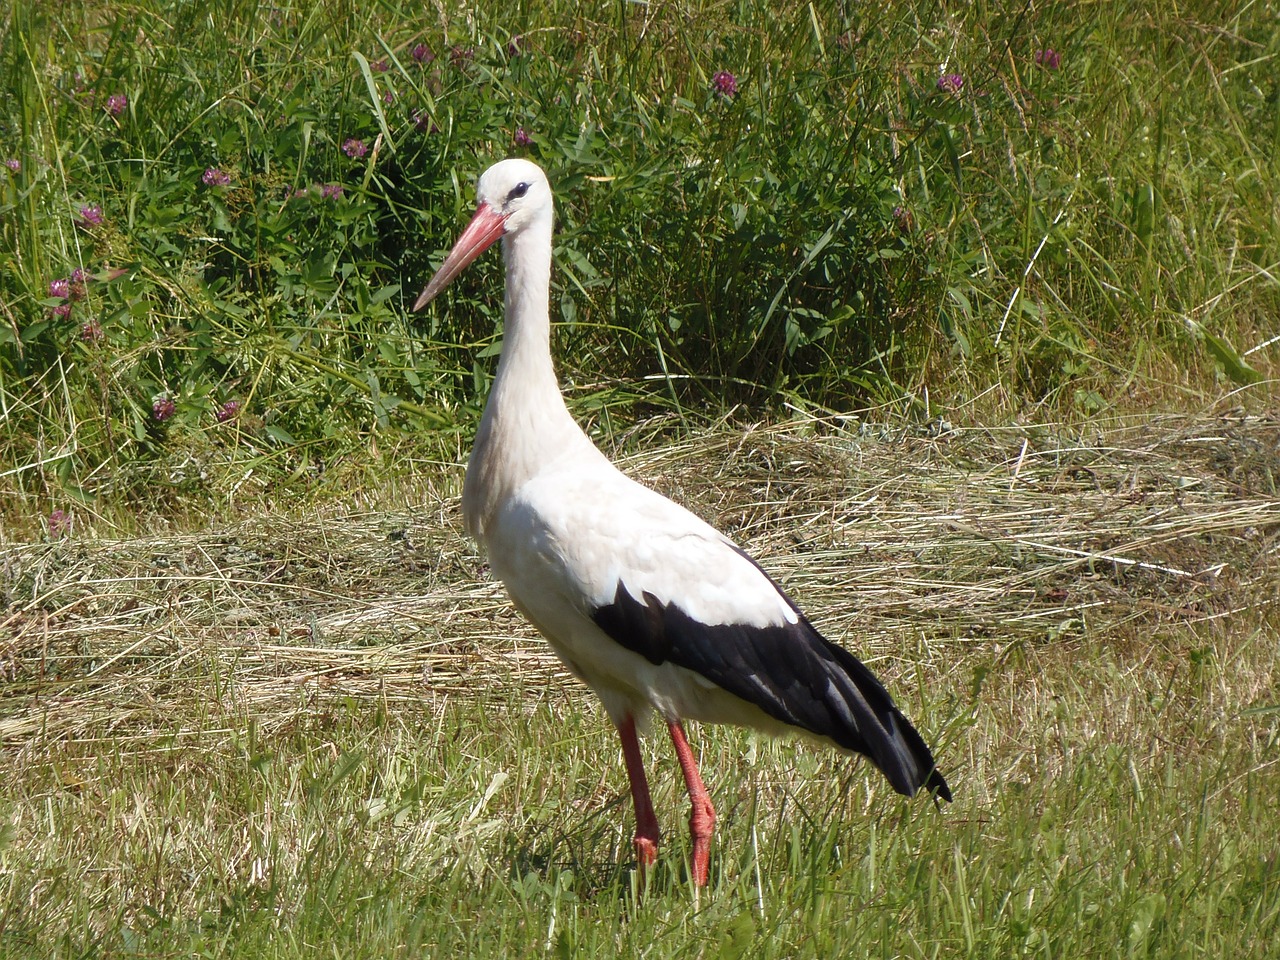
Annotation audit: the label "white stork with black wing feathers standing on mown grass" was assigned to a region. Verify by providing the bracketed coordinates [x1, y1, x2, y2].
[413, 159, 951, 886]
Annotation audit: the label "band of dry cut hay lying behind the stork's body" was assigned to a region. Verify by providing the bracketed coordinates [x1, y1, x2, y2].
[0, 416, 1280, 754]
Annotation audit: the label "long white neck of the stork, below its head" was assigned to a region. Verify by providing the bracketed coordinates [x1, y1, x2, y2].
[462, 211, 591, 545]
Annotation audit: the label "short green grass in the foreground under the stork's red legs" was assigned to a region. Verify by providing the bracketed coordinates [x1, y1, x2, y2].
[0, 675, 1280, 960]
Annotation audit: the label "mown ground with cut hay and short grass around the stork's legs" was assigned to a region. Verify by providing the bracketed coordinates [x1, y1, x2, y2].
[0, 415, 1280, 957]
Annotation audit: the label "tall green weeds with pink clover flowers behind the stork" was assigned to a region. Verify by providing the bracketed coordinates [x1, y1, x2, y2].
[0, 0, 1280, 519]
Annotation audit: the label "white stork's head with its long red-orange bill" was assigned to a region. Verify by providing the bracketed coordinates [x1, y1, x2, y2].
[413, 157, 552, 310]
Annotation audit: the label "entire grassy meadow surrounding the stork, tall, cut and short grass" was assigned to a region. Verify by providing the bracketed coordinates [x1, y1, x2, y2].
[0, 0, 1280, 960]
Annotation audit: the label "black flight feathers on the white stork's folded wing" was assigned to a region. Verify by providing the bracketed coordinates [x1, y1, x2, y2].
[591, 578, 951, 800]
